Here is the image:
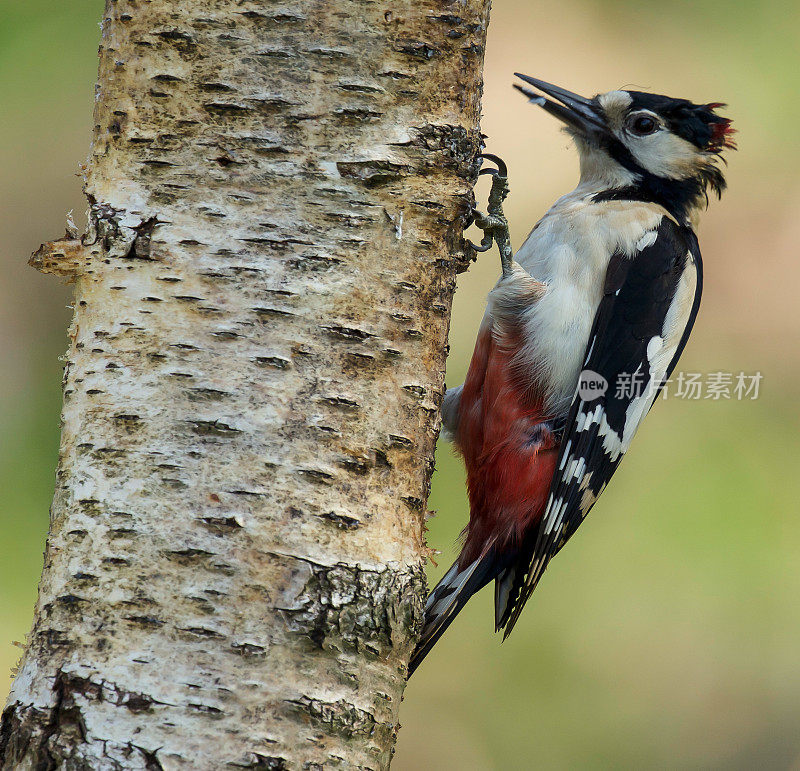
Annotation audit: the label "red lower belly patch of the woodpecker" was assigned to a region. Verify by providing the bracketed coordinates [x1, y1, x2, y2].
[457, 323, 558, 565]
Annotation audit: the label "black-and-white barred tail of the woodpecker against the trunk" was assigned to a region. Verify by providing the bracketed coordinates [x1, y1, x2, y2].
[408, 549, 501, 677]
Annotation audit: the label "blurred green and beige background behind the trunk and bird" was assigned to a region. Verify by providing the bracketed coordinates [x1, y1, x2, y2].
[0, 0, 800, 771]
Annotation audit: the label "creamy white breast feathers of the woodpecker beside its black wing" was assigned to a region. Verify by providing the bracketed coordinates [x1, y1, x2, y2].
[515, 187, 666, 414]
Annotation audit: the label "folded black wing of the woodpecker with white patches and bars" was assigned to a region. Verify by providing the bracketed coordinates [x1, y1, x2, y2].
[498, 217, 702, 637]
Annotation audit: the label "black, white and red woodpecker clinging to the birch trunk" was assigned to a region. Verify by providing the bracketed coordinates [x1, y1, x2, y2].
[409, 73, 735, 674]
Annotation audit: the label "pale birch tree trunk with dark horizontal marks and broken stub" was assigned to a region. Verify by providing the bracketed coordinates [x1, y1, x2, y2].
[0, 0, 489, 769]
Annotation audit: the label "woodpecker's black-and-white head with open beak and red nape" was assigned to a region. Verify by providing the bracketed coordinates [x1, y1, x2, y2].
[515, 73, 735, 219]
